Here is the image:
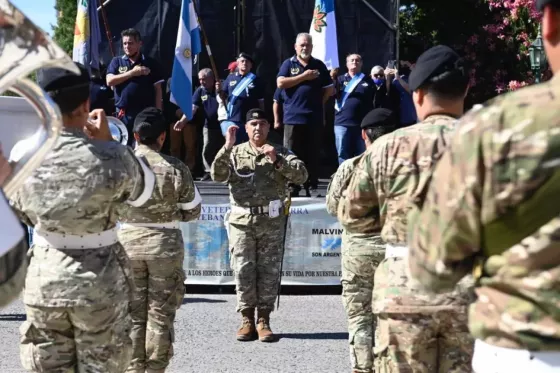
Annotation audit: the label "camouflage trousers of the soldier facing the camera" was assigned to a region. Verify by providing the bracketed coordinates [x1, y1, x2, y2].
[228, 212, 286, 312]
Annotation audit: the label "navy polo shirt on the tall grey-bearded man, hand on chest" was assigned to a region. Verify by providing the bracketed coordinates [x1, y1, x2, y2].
[278, 56, 333, 124]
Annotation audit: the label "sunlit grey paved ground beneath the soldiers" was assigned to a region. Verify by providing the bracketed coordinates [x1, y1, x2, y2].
[0, 294, 350, 373]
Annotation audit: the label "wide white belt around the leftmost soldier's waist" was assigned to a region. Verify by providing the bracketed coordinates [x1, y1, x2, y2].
[33, 228, 119, 249]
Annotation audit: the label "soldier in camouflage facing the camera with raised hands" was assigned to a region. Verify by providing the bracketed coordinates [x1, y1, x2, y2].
[212, 109, 307, 342]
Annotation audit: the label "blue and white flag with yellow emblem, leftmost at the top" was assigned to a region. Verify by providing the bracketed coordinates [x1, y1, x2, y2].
[72, 0, 101, 73]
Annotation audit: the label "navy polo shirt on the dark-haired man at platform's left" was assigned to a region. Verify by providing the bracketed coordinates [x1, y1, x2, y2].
[107, 55, 165, 115]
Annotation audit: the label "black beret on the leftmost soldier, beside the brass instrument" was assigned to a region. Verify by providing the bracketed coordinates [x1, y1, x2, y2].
[37, 63, 91, 94]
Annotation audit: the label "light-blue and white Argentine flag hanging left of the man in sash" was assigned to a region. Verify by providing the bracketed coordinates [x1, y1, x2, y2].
[171, 0, 201, 120]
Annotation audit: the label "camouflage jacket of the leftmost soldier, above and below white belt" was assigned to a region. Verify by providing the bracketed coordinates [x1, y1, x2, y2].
[10, 129, 151, 307]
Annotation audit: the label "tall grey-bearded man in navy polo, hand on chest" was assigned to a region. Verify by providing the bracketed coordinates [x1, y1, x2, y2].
[276, 33, 334, 196]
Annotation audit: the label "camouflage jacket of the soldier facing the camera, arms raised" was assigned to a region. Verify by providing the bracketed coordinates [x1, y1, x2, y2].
[211, 142, 307, 224]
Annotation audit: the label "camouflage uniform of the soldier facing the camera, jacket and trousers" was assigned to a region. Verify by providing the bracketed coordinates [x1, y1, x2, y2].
[212, 142, 307, 324]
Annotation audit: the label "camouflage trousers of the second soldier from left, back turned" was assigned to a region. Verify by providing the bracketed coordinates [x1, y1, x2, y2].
[128, 255, 185, 373]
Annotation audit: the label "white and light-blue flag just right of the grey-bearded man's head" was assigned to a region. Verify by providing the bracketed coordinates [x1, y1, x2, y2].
[309, 0, 339, 70]
